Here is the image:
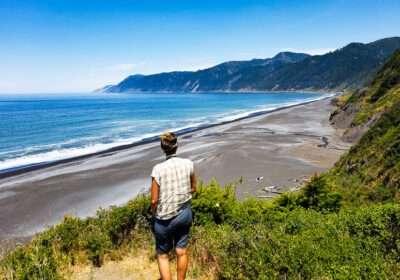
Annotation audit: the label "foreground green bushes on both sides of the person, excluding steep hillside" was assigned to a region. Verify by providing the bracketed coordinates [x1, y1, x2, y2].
[1, 182, 400, 279]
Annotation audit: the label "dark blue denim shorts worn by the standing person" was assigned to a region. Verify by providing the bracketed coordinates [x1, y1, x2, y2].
[154, 204, 193, 254]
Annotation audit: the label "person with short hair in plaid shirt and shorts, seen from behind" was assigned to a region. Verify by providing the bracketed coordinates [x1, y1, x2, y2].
[151, 131, 196, 280]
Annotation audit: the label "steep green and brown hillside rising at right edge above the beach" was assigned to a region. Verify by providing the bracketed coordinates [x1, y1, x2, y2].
[324, 49, 400, 203]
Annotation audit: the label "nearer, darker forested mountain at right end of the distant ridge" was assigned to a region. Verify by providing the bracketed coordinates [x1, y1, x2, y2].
[256, 38, 400, 90]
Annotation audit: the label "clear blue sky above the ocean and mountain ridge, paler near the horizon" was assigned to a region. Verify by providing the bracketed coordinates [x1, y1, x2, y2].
[0, 0, 400, 93]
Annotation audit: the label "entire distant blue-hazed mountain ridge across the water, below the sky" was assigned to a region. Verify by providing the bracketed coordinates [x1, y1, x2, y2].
[97, 37, 400, 93]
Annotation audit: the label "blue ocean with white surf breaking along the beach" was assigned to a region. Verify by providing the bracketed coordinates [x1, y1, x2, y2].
[0, 92, 331, 173]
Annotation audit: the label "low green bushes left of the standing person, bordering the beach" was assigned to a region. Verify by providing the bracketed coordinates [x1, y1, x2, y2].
[0, 196, 151, 279]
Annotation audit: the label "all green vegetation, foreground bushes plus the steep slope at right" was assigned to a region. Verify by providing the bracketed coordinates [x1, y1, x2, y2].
[0, 50, 400, 279]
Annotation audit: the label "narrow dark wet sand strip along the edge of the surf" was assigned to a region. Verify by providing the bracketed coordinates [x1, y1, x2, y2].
[0, 91, 340, 180]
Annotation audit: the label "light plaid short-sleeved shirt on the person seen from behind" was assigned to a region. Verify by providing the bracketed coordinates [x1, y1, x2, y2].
[151, 157, 193, 220]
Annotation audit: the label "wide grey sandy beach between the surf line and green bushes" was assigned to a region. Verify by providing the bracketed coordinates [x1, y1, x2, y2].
[0, 99, 349, 239]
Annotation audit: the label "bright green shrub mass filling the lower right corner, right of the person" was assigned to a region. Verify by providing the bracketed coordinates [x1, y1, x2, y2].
[191, 204, 400, 279]
